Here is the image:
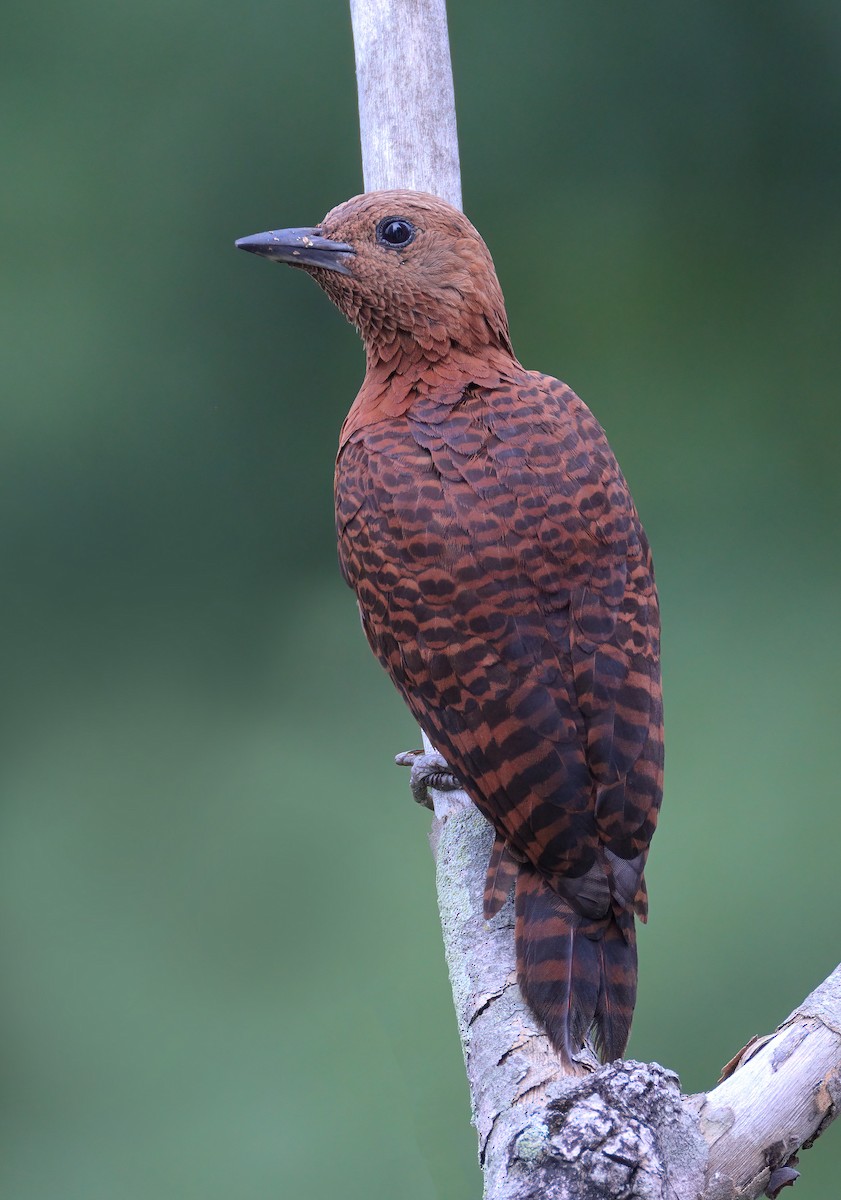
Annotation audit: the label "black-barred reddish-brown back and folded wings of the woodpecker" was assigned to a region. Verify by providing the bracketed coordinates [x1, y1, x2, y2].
[336, 372, 662, 917]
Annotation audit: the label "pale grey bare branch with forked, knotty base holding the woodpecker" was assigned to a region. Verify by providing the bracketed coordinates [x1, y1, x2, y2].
[350, 0, 841, 1200]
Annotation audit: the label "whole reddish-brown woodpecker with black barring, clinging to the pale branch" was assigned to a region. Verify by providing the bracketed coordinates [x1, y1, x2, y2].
[236, 190, 663, 1070]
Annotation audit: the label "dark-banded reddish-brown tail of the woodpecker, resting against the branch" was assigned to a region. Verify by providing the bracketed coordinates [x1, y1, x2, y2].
[516, 865, 637, 1066]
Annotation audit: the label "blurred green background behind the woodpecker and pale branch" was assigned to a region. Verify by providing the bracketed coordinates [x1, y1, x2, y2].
[0, 0, 841, 1200]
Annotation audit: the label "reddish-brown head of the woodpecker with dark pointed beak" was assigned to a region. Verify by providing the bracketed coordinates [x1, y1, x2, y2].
[236, 191, 511, 360]
